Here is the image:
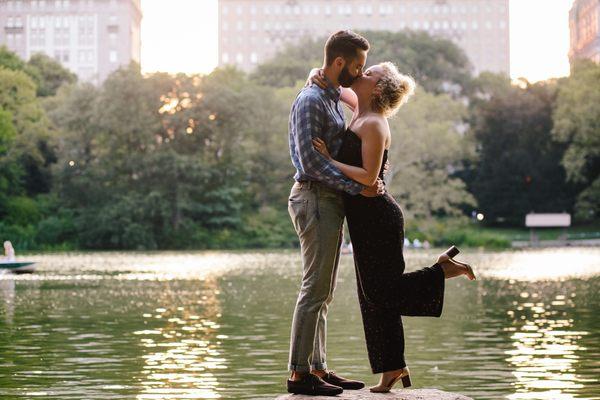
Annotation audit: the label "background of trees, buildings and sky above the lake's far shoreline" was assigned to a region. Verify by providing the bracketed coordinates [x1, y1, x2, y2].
[0, 0, 600, 249]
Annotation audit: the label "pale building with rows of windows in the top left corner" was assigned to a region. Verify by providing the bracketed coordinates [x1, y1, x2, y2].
[0, 0, 142, 84]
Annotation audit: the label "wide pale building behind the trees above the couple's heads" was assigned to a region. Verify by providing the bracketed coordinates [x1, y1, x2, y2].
[219, 0, 510, 75]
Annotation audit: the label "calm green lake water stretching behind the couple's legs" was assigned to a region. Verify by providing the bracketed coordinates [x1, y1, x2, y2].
[0, 248, 600, 400]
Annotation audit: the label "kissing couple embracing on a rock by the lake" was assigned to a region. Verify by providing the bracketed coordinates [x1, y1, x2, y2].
[287, 31, 475, 396]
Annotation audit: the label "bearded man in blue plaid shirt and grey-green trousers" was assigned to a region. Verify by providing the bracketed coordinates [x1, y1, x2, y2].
[287, 31, 383, 395]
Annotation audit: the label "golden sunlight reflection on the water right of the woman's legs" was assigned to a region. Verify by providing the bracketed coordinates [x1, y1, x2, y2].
[506, 292, 589, 400]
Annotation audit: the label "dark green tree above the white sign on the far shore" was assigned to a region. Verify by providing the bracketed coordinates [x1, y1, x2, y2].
[466, 82, 577, 226]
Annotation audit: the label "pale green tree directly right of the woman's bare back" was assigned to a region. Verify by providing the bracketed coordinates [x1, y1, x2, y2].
[388, 89, 475, 219]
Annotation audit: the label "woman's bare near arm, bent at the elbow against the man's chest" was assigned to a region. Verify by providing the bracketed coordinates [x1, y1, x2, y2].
[313, 122, 385, 186]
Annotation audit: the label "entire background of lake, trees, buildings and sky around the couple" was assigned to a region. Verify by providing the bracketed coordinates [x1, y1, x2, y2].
[0, 0, 600, 400]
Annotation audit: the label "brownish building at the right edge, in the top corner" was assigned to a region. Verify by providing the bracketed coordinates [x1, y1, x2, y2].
[569, 0, 600, 64]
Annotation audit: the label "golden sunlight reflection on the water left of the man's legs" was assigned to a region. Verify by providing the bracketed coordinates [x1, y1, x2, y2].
[134, 278, 227, 399]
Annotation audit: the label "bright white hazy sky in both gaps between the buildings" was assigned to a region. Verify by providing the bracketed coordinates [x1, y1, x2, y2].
[142, 0, 573, 81]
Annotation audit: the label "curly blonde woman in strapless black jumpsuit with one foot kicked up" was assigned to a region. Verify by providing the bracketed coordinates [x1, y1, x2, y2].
[312, 62, 475, 392]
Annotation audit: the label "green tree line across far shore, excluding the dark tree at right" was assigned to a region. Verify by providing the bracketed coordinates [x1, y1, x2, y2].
[0, 38, 600, 250]
